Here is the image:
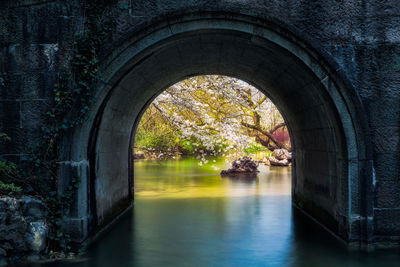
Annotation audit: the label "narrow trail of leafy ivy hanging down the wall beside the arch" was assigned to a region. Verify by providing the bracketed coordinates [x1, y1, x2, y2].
[45, 0, 117, 251]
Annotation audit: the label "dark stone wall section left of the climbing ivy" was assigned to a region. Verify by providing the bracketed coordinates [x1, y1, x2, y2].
[0, 1, 82, 160]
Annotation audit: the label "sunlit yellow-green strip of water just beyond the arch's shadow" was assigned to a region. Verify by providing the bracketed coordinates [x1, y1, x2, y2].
[135, 158, 291, 200]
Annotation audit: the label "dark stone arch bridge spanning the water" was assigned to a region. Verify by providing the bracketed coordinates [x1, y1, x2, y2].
[0, 0, 400, 250]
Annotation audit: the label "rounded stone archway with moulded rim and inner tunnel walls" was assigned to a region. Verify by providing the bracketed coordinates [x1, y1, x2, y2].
[65, 13, 372, 247]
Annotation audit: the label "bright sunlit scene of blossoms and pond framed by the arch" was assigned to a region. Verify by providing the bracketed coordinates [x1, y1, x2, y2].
[133, 75, 291, 200]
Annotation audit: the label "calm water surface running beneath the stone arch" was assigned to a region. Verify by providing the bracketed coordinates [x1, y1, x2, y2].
[28, 159, 400, 267]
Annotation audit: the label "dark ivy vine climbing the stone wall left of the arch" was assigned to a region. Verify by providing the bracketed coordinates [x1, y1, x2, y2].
[12, 0, 117, 252]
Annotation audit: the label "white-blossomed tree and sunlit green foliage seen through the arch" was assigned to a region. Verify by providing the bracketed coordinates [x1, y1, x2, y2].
[135, 75, 290, 158]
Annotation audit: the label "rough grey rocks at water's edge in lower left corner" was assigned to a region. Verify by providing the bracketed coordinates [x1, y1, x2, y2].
[0, 197, 47, 265]
